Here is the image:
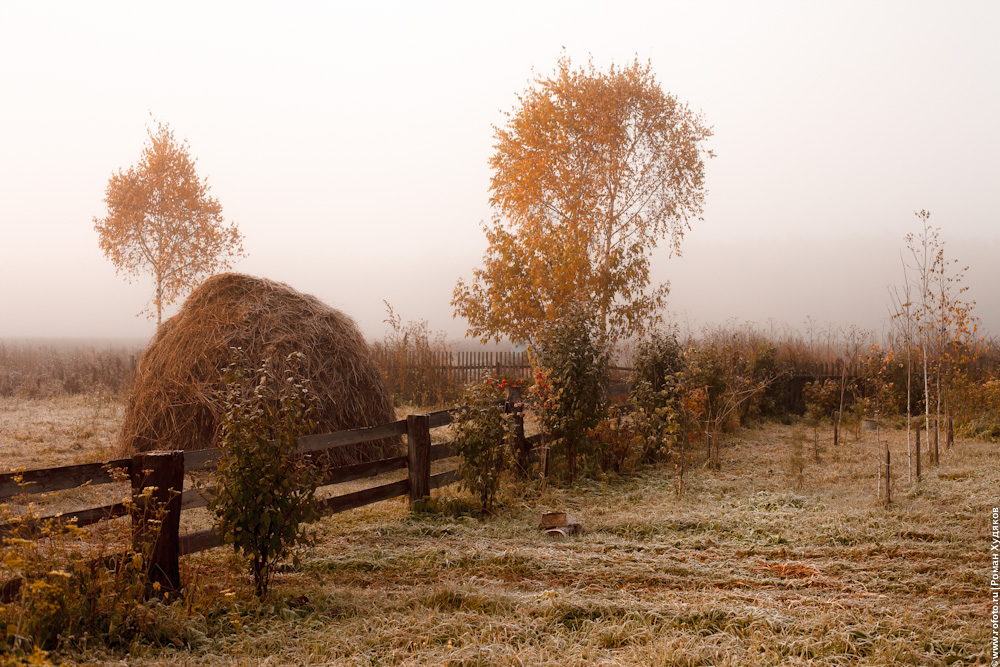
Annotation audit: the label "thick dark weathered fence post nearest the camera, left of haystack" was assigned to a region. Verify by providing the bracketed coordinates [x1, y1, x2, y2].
[130, 452, 184, 591]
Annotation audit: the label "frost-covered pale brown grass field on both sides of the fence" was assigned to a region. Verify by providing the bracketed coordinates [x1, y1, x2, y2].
[0, 397, 1000, 666]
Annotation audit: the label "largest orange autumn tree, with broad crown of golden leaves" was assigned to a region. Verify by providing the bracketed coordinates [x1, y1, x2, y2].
[452, 56, 712, 342]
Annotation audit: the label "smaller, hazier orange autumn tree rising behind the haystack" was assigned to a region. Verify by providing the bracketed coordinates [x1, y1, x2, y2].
[94, 123, 245, 327]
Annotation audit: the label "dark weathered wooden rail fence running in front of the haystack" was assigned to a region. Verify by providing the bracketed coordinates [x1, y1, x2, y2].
[0, 400, 539, 597]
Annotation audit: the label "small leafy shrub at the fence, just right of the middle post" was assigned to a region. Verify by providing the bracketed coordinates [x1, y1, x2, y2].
[454, 378, 516, 514]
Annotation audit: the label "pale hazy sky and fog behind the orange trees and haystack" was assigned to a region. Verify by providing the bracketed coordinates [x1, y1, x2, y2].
[0, 0, 1000, 338]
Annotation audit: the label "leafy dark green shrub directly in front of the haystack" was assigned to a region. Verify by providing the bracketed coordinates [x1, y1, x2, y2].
[210, 350, 321, 598]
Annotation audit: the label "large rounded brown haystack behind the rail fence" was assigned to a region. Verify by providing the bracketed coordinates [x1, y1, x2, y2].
[120, 273, 400, 463]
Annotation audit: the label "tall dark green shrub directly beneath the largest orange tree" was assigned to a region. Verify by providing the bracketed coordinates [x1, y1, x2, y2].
[531, 311, 610, 483]
